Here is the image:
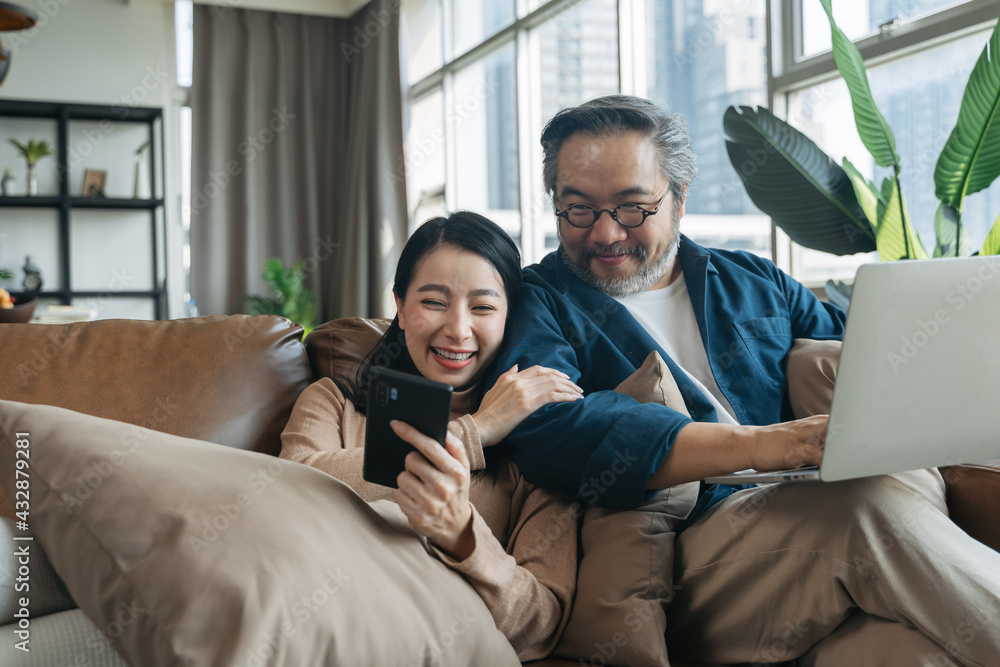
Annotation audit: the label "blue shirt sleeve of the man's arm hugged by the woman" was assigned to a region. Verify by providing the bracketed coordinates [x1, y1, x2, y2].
[497, 286, 691, 508]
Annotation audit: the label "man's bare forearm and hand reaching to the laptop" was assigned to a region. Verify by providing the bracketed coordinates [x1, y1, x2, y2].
[646, 415, 829, 489]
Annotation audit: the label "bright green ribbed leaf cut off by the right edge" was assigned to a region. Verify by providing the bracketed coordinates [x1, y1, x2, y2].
[934, 22, 1000, 213]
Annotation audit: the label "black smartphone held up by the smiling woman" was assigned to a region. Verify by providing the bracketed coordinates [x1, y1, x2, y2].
[362, 368, 452, 488]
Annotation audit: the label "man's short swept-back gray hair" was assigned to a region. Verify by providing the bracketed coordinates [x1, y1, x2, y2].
[542, 95, 698, 210]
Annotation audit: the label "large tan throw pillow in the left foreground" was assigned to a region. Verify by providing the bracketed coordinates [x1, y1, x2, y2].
[0, 401, 519, 667]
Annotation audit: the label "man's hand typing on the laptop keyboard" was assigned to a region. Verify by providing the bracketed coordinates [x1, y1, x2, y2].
[749, 415, 830, 470]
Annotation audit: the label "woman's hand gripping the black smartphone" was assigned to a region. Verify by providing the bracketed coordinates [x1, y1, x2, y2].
[390, 420, 476, 560]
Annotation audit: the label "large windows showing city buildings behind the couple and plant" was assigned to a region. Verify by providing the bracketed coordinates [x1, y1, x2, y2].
[403, 0, 1000, 283]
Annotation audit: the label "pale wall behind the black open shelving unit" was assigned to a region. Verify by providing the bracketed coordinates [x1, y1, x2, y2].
[0, 0, 184, 317]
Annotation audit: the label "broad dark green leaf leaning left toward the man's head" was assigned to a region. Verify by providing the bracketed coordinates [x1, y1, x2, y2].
[722, 107, 875, 255]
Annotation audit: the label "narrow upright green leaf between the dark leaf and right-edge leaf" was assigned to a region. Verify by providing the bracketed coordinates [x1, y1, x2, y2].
[820, 0, 899, 168]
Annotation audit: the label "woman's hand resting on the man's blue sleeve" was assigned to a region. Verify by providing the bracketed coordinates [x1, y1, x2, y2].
[472, 365, 583, 447]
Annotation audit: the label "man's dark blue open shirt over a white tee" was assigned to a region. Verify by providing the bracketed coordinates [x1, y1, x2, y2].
[491, 236, 845, 523]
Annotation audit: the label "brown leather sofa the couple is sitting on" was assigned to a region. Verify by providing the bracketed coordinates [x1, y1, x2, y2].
[0, 315, 1000, 666]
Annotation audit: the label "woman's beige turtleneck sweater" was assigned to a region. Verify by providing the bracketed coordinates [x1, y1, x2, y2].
[281, 378, 582, 661]
